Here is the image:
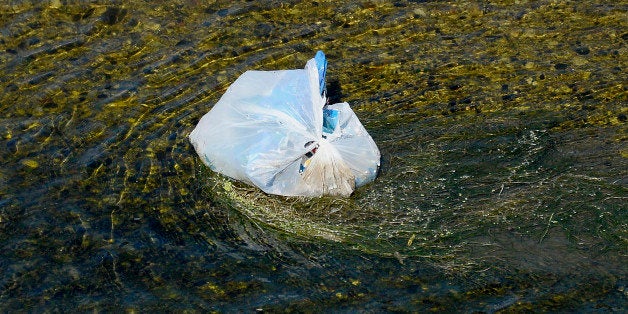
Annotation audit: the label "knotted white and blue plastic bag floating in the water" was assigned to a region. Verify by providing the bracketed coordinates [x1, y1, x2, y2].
[190, 51, 380, 196]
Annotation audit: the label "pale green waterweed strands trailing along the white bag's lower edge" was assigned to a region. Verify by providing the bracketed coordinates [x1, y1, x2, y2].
[201, 167, 479, 274]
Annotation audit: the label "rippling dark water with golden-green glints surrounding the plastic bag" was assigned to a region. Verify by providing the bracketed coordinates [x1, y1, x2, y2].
[0, 0, 628, 312]
